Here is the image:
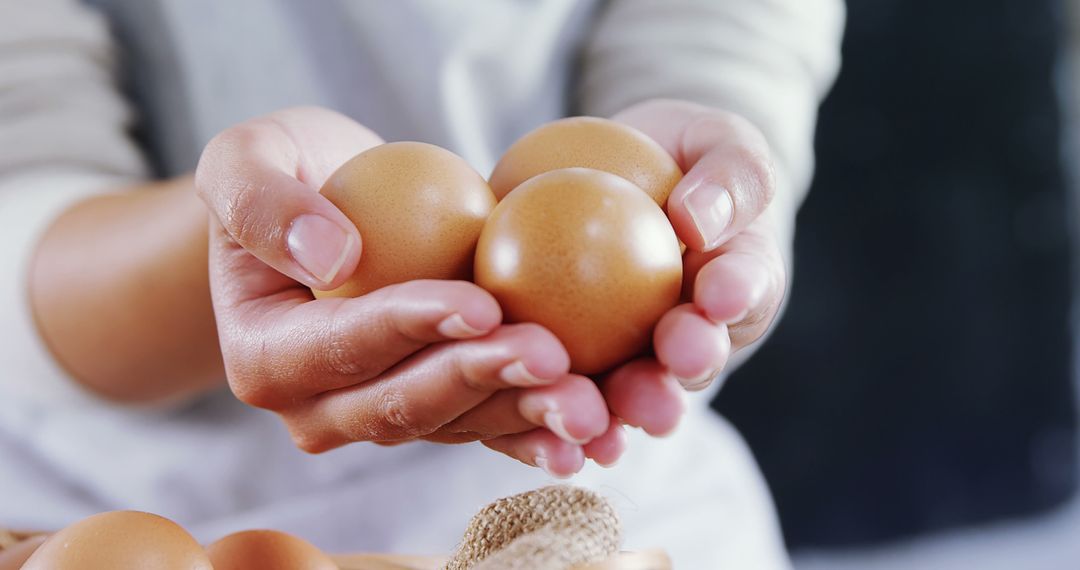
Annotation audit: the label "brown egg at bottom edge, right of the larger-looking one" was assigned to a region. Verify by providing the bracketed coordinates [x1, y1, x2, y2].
[206, 530, 338, 570]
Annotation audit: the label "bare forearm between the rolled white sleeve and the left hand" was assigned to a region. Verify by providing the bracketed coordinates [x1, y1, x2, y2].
[29, 178, 224, 403]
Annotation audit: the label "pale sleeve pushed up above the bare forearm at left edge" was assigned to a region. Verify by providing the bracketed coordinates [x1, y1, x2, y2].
[0, 0, 146, 408]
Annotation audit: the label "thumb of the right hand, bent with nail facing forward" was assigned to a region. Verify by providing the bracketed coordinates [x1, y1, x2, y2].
[616, 100, 775, 252]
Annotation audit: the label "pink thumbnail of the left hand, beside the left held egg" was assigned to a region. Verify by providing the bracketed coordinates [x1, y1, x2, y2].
[287, 214, 356, 283]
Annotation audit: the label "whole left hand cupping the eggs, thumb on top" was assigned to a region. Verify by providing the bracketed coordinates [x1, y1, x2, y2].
[195, 108, 625, 475]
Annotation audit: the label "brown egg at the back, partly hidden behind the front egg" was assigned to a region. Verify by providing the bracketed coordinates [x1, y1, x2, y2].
[491, 117, 683, 207]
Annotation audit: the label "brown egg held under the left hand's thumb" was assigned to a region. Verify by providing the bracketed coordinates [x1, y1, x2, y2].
[314, 143, 496, 298]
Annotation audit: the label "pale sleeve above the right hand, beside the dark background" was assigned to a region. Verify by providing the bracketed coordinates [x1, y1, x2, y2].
[582, 0, 846, 221]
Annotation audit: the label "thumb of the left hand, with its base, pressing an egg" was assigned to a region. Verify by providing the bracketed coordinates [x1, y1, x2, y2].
[195, 108, 381, 289]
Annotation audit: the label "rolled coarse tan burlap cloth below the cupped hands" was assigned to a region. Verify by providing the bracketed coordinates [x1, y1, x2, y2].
[445, 485, 622, 570]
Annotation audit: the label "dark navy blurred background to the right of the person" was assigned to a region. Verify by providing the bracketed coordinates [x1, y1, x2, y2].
[715, 0, 1078, 549]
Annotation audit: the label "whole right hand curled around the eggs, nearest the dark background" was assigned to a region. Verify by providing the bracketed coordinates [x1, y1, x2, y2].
[603, 100, 794, 435]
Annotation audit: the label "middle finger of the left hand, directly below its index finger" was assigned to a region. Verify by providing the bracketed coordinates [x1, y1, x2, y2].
[283, 324, 574, 451]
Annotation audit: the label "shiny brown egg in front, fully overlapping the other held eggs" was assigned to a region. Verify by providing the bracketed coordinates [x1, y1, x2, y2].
[476, 168, 683, 374]
